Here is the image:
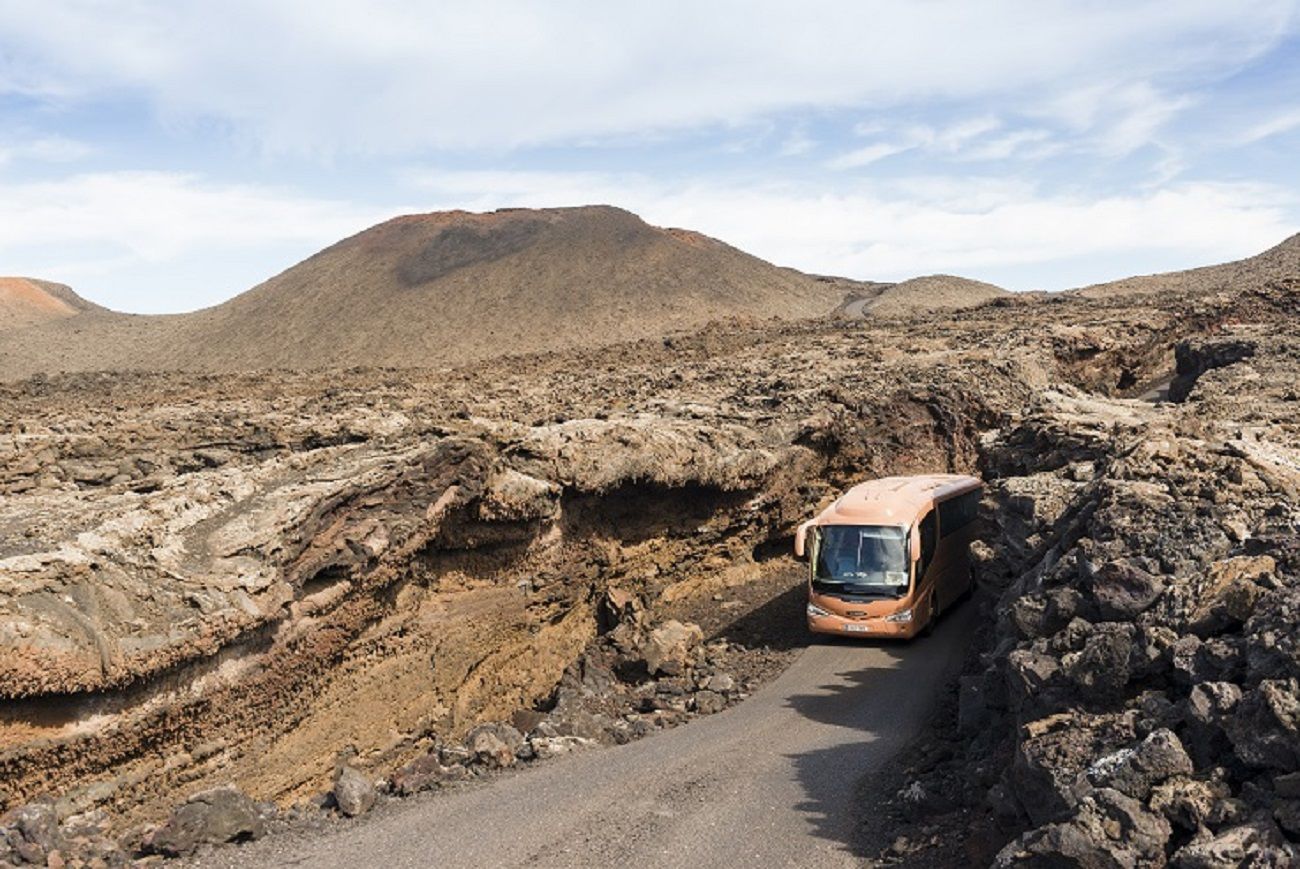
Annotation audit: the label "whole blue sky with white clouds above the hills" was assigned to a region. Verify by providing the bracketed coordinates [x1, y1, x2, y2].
[0, 0, 1300, 314]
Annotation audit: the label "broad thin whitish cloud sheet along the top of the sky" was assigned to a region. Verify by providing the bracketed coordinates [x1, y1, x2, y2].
[0, 0, 1294, 152]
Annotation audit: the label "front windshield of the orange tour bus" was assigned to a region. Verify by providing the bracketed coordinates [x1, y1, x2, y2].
[813, 526, 907, 597]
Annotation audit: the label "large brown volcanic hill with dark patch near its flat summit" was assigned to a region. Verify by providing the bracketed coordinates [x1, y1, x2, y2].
[0, 206, 842, 377]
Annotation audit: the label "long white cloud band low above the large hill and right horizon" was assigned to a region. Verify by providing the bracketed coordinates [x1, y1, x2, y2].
[412, 172, 1296, 289]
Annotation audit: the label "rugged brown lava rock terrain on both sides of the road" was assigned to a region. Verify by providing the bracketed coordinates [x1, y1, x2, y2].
[0, 215, 1300, 866]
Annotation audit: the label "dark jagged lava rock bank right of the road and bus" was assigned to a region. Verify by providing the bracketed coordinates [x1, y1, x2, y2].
[889, 304, 1300, 866]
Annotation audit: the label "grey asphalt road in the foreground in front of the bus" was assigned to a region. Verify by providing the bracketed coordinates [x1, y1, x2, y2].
[203, 604, 975, 869]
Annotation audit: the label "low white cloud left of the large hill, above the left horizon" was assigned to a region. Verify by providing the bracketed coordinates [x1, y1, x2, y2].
[0, 172, 393, 311]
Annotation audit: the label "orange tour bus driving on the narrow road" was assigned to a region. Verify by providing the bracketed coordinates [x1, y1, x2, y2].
[794, 474, 984, 637]
